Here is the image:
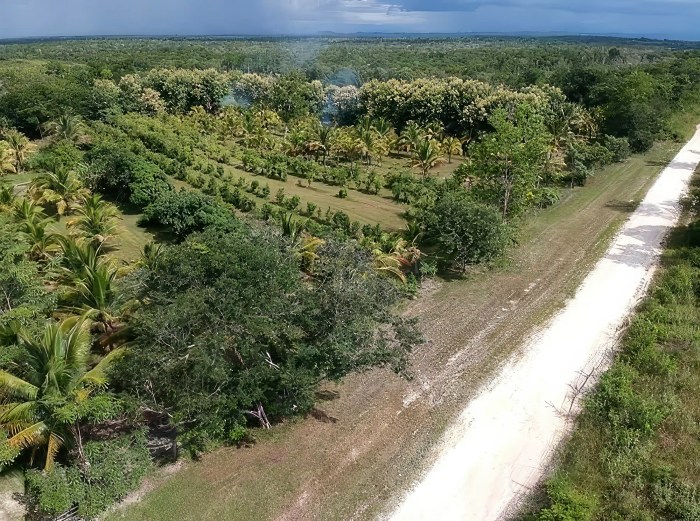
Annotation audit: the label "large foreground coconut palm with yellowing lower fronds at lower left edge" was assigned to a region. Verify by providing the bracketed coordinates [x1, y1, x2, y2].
[0, 317, 124, 471]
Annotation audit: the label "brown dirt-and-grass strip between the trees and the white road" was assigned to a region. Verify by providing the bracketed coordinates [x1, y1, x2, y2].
[110, 138, 678, 521]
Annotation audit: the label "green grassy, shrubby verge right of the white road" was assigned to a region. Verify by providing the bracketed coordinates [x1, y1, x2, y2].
[524, 168, 700, 521]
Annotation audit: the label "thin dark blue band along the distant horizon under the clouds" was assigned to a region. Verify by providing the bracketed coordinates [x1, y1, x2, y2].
[0, 31, 700, 43]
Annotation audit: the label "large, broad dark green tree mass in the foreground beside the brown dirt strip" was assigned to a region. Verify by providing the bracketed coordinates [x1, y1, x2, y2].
[120, 223, 415, 442]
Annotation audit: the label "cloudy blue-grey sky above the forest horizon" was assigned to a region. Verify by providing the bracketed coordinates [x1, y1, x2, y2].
[0, 0, 700, 40]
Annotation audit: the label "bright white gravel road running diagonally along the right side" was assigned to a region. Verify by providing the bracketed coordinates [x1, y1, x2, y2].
[391, 130, 700, 521]
